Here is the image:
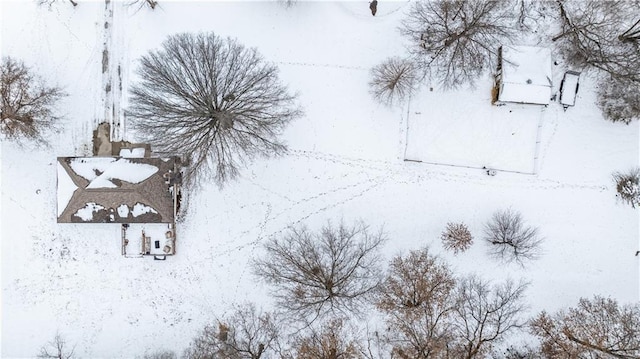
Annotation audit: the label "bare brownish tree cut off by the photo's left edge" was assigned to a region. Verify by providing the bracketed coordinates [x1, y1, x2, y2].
[0, 57, 65, 143]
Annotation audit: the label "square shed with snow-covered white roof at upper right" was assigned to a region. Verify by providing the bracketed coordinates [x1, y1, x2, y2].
[494, 46, 552, 105]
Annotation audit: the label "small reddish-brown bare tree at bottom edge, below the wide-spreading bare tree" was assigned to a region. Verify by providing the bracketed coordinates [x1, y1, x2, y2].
[283, 318, 364, 359]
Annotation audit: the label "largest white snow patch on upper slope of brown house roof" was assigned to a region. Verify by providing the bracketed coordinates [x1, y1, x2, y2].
[69, 157, 158, 188]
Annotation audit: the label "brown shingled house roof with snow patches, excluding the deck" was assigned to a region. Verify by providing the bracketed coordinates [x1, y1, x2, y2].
[57, 157, 175, 223]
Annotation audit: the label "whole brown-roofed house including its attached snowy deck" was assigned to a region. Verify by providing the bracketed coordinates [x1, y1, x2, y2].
[57, 155, 182, 259]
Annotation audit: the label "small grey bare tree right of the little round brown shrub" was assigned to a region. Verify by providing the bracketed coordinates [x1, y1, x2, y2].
[484, 209, 542, 265]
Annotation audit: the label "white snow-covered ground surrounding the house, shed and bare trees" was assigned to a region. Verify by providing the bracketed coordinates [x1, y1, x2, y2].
[0, 0, 640, 358]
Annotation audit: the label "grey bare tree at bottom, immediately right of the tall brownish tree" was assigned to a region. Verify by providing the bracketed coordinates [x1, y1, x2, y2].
[453, 275, 527, 359]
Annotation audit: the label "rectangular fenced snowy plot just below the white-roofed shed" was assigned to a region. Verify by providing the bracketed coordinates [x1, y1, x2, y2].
[405, 83, 544, 174]
